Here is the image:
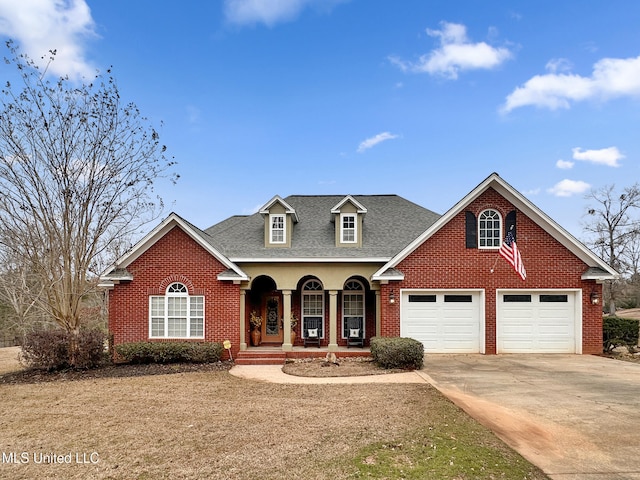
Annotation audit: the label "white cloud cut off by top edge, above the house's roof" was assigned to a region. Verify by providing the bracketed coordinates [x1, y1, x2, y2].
[224, 0, 345, 27]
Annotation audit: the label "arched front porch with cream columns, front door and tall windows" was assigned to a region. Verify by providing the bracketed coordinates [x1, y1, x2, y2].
[240, 274, 382, 352]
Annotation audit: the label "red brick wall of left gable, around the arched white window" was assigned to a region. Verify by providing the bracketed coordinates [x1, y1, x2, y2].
[109, 227, 240, 353]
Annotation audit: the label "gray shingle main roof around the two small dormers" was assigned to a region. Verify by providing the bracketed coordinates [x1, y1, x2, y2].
[205, 195, 440, 260]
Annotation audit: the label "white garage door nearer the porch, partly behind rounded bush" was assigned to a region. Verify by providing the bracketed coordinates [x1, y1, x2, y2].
[400, 290, 480, 353]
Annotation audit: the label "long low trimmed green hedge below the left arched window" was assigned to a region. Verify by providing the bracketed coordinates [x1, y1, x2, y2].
[115, 342, 224, 363]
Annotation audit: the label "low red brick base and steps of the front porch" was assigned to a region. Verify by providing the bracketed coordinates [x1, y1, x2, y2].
[235, 346, 371, 365]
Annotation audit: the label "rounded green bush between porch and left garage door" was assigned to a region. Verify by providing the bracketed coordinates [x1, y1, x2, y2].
[371, 337, 424, 370]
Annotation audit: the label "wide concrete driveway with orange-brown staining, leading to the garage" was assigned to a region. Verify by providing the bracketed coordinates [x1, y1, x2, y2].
[421, 355, 640, 480]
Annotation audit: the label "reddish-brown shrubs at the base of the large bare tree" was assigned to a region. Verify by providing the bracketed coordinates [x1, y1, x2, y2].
[20, 329, 106, 371]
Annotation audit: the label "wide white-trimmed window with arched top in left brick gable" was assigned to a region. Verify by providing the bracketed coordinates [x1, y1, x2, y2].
[149, 282, 204, 338]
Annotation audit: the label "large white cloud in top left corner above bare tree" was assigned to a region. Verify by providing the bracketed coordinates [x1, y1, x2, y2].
[0, 0, 97, 79]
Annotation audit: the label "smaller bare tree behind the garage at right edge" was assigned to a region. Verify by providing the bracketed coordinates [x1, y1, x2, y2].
[584, 183, 640, 314]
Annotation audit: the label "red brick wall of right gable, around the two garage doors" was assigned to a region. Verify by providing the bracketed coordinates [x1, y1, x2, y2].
[382, 189, 602, 354]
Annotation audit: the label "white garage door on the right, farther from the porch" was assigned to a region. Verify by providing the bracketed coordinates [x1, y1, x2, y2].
[496, 290, 576, 353]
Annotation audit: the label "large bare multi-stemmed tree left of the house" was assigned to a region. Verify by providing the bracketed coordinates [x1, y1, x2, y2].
[0, 42, 177, 364]
